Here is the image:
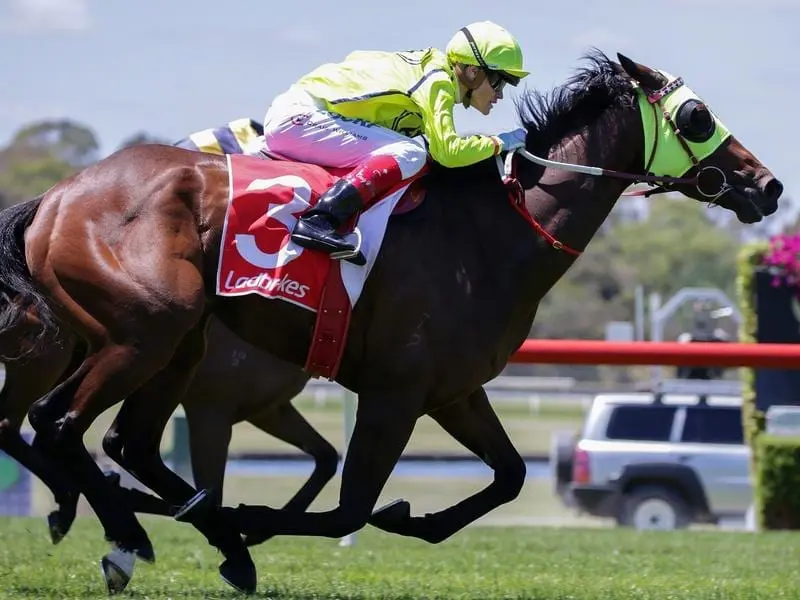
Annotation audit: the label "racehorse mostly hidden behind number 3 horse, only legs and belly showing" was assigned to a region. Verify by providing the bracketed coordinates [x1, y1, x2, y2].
[0, 311, 332, 591]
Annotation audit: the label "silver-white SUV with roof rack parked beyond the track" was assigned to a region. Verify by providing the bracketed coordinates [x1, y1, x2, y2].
[570, 382, 753, 529]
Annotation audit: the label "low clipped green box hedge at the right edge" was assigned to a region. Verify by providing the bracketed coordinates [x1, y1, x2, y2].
[755, 434, 800, 529]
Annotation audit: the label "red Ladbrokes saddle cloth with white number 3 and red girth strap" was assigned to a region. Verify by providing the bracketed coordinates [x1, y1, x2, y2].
[216, 154, 426, 380]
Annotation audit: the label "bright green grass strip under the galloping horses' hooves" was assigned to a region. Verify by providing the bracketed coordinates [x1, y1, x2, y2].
[0, 518, 800, 600]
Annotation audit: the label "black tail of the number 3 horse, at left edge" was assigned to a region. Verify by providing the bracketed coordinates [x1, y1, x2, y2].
[0, 196, 59, 358]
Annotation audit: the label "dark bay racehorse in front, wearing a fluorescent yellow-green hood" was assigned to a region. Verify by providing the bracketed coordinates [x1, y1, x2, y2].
[0, 54, 782, 592]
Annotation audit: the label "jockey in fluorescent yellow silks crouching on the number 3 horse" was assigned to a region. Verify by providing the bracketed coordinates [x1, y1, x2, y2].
[264, 21, 528, 259]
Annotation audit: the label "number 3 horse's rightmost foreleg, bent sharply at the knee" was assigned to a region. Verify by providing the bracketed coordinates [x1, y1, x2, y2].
[370, 388, 525, 543]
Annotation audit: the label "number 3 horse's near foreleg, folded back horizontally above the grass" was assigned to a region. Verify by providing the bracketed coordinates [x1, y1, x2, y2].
[176, 389, 424, 538]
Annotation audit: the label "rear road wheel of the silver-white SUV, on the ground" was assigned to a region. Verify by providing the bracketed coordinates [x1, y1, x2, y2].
[618, 486, 690, 530]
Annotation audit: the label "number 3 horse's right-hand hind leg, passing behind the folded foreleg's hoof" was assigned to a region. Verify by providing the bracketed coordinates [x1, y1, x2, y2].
[103, 319, 256, 592]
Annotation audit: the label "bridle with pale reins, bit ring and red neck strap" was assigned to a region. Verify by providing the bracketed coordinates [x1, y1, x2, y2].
[504, 77, 733, 256]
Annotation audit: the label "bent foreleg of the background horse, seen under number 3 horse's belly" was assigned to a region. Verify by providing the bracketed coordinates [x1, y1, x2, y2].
[238, 402, 339, 546]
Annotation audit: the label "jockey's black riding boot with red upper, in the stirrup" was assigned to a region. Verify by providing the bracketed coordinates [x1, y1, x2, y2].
[291, 156, 402, 264]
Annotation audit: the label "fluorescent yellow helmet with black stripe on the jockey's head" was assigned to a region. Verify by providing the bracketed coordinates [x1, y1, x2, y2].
[445, 21, 528, 85]
